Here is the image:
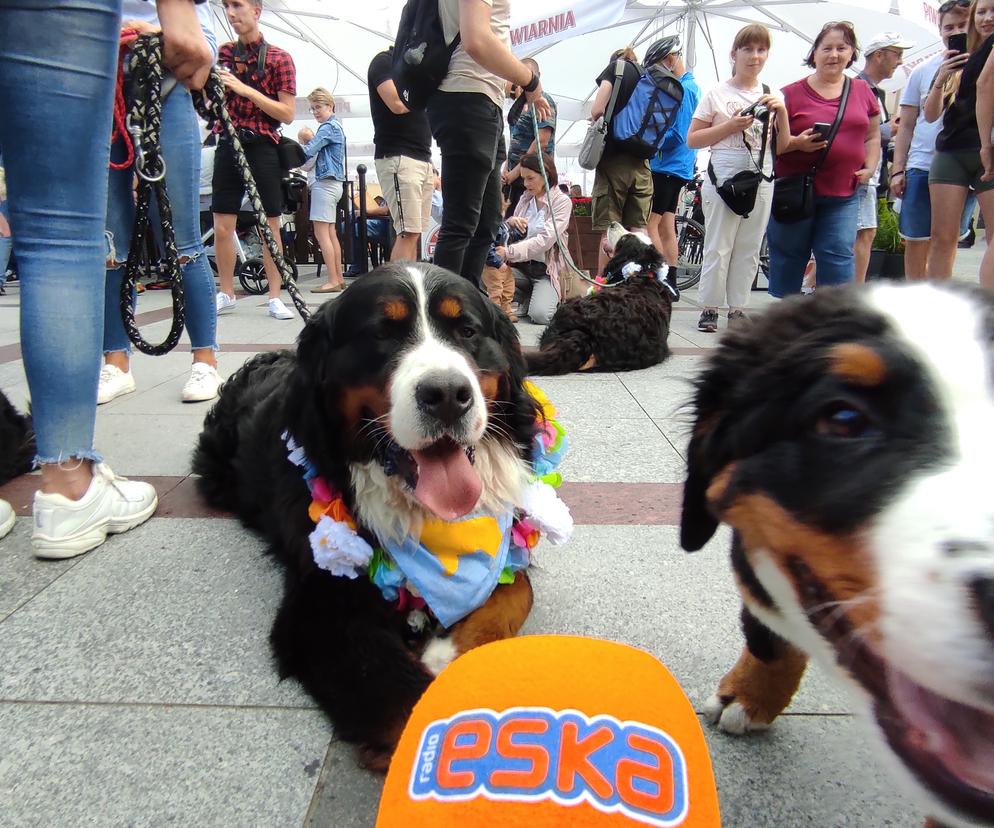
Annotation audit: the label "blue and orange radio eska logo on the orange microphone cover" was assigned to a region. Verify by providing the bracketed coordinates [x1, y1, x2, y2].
[409, 707, 688, 826]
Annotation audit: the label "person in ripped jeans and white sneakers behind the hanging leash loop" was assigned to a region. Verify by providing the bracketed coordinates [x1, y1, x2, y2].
[97, 8, 221, 405]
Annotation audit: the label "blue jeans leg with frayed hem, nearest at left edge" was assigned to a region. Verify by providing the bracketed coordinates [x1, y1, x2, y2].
[0, 0, 121, 463]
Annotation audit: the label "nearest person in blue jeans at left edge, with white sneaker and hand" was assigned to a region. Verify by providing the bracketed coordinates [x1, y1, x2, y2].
[0, 0, 210, 558]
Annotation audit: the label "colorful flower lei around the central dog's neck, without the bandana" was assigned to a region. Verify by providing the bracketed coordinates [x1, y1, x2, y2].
[282, 381, 573, 630]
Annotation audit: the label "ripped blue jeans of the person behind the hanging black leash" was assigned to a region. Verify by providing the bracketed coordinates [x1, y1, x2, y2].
[104, 85, 217, 353]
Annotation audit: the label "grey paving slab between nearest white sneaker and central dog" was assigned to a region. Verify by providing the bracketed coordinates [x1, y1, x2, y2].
[0, 519, 314, 708]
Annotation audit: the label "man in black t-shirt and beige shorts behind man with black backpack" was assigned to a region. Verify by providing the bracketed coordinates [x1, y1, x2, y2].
[367, 46, 435, 262]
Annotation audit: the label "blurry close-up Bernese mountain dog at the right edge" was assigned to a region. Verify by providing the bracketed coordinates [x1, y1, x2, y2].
[681, 285, 994, 826]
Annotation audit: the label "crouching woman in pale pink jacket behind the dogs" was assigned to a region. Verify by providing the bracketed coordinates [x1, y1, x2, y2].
[495, 152, 573, 325]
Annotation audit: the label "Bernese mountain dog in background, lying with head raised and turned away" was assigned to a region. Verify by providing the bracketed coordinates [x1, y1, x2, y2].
[527, 222, 677, 375]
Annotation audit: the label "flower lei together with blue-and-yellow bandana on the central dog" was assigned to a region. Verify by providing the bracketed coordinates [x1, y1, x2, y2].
[283, 381, 573, 630]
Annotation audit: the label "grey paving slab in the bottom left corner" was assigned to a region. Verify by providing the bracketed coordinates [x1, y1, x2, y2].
[0, 702, 334, 828]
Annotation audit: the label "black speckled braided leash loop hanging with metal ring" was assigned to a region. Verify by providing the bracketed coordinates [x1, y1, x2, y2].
[121, 33, 184, 356]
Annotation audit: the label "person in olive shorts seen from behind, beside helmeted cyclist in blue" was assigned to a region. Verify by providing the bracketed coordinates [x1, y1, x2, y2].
[590, 48, 652, 272]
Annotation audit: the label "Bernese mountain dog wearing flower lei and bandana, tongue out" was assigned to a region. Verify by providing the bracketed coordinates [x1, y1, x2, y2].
[193, 264, 568, 770]
